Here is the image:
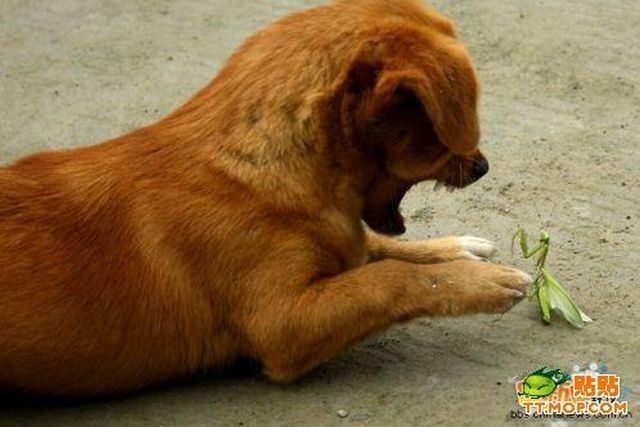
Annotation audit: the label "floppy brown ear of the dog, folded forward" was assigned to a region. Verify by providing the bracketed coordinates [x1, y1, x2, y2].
[341, 44, 480, 154]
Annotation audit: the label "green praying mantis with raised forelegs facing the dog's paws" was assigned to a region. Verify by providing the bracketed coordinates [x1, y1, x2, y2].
[511, 227, 593, 328]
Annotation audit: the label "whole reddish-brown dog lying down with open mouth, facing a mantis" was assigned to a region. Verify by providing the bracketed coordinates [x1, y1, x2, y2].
[0, 0, 530, 395]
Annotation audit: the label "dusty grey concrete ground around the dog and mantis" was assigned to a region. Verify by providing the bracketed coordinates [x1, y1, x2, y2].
[0, 0, 640, 426]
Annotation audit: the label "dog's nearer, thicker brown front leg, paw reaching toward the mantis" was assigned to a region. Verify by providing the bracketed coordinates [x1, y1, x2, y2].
[246, 260, 531, 381]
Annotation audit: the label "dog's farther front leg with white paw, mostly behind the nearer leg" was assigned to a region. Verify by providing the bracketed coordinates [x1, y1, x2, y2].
[367, 230, 495, 264]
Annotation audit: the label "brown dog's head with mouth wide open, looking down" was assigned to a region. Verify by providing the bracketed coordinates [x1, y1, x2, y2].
[332, 4, 489, 234]
